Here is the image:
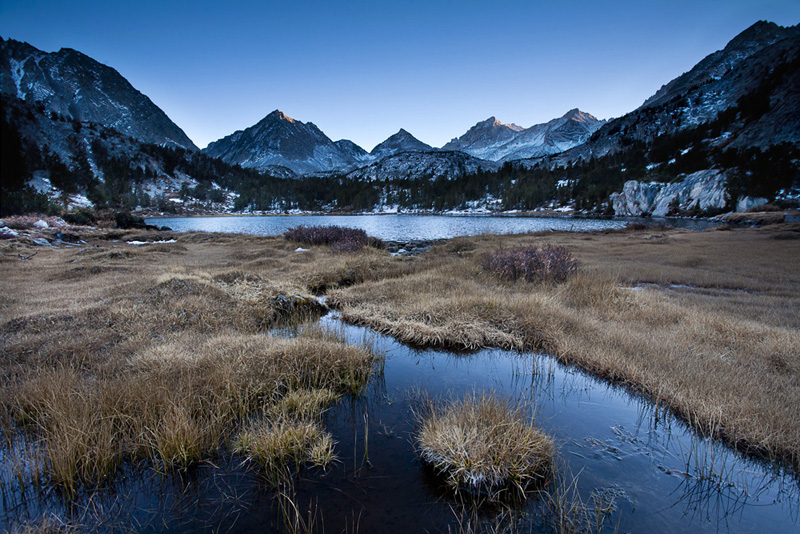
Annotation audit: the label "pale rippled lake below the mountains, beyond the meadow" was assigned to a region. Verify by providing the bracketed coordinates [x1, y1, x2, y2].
[147, 215, 716, 241]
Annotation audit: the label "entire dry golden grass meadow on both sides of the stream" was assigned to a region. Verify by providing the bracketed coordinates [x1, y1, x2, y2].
[0, 225, 800, 496]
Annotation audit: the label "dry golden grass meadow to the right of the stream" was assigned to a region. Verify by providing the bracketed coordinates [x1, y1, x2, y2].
[329, 225, 800, 466]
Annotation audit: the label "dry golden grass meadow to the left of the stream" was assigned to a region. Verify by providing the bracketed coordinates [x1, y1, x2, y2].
[0, 234, 388, 494]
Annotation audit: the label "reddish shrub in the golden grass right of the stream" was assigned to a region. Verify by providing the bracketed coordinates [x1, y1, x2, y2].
[481, 244, 578, 282]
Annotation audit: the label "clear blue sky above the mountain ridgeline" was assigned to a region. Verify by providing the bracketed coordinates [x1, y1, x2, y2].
[0, 0, 800, 150]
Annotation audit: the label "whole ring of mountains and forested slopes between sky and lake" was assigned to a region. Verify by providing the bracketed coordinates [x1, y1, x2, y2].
[0, 21, 800, 215]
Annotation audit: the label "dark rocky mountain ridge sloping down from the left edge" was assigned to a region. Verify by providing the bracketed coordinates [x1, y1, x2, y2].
[0, 38, 197, 150]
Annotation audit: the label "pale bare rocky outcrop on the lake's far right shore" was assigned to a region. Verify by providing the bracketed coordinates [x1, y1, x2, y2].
[611, 169, 729, 217]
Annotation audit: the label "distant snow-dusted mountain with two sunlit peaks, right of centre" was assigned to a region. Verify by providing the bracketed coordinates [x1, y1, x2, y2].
[442, 109, 605, 161]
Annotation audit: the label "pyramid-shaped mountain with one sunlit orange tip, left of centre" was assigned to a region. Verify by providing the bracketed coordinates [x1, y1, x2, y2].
[204, 110, 363, 174]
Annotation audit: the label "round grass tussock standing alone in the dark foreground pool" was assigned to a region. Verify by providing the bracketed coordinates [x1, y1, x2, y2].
[416, 394, 554, 497]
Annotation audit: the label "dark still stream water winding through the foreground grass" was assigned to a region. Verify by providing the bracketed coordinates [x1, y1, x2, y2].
[0, 315, 800, 534]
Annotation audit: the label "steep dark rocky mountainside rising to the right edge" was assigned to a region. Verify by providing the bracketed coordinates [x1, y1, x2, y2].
[551, 21, 800, 165]
